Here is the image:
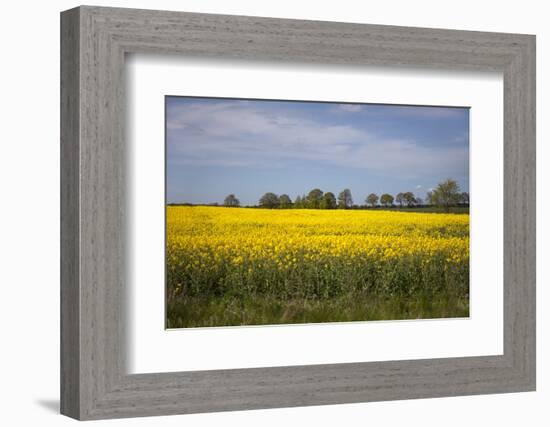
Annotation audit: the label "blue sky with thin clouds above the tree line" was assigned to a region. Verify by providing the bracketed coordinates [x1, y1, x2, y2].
[166, 96, 469, 205]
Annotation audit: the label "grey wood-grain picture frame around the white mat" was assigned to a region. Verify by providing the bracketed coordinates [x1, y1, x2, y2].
[61, 6, 535, 420]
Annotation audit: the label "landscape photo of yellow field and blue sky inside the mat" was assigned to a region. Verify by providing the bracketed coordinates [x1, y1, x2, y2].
[165, 96, 470, 328]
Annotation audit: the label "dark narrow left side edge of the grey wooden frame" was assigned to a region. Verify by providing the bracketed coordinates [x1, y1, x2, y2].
[60, 10, 80, 417]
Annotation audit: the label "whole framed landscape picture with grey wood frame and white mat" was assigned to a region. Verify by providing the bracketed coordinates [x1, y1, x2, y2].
[61, 6, 536, 420]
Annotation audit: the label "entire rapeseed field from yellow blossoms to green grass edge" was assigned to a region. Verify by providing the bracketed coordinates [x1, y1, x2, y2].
[166, 206, 469, 328]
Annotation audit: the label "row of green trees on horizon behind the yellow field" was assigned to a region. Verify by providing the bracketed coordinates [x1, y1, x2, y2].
[223, 178, 470, 210]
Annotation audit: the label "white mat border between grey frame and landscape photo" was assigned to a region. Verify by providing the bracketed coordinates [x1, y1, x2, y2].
[126, 55, 503, 373]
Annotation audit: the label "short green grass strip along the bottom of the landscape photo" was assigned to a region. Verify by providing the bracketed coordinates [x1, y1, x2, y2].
[166, 293, 469, 328]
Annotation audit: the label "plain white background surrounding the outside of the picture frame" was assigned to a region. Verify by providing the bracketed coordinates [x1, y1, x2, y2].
[0, 0, 550, 427]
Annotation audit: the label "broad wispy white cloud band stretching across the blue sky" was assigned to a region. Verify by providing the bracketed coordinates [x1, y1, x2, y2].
[167, 101, 468, 179]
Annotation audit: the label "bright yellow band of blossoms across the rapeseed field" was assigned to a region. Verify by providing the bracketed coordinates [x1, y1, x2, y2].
[167, 206, 470, 274]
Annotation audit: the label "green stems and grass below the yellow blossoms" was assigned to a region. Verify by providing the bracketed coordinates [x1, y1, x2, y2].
[166, 257, 469, 328]
